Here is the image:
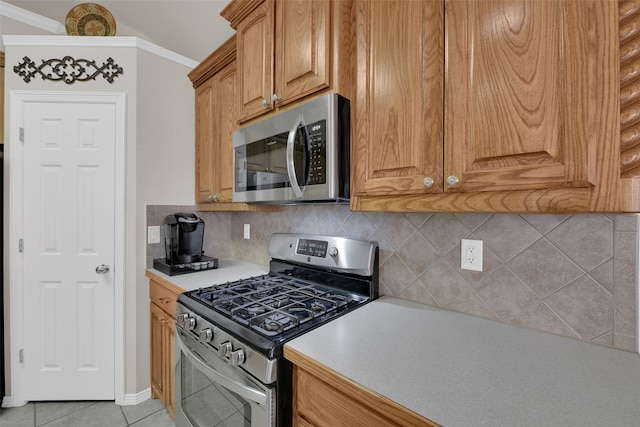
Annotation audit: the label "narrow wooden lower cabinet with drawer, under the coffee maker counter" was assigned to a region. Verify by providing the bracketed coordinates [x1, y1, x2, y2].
[147, 273, 183, 417]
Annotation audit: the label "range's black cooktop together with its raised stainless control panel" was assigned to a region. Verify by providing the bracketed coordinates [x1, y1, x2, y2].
[177, 234, 378, 358]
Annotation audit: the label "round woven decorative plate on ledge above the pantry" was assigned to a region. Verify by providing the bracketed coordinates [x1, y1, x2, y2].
[65, 3, 116, 36]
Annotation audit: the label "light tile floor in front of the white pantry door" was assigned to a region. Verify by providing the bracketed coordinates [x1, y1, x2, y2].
[0, 399, 174, 427]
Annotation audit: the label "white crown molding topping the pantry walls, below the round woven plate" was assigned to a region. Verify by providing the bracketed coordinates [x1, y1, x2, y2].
[2, 35, 198, 69]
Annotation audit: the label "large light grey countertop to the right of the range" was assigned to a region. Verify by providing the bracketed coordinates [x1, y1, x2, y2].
[286, 297, 640, 427]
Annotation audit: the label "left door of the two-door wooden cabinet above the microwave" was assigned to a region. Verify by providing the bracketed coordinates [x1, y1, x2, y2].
[236, 0, 275, 121]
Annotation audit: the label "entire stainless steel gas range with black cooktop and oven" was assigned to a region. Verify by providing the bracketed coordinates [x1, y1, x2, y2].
[175, 233, 379, 427]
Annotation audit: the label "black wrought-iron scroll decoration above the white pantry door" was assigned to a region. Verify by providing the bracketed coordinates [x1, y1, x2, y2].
[13, 56, 123, 84]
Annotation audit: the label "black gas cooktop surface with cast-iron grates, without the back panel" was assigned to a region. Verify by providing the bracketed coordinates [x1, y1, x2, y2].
[178, 263, 372, 357]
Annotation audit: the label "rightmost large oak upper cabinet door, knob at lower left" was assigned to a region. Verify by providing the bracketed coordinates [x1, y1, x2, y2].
[445, 0, 596, 191]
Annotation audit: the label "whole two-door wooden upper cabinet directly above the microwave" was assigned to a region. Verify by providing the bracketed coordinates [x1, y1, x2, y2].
[221, 0, 353, 122]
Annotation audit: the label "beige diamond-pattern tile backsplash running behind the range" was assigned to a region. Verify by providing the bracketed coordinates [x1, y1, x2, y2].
[147, 205, 640, 352]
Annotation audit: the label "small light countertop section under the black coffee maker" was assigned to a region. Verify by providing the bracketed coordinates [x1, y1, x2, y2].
[147, 259, 269, 291]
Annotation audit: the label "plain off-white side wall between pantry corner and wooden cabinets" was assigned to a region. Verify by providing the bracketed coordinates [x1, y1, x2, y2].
[134, 48, 195, 391]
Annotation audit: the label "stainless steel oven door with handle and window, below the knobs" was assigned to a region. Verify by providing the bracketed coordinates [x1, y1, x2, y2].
[175, 329, 276, 427]
